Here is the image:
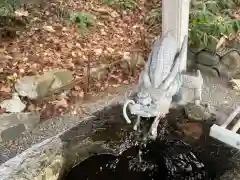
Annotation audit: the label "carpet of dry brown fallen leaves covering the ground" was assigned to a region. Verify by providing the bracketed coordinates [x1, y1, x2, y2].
[0, 0, 156, 119]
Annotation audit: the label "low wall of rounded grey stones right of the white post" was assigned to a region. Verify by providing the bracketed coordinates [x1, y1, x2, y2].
[188, 40, 240, 79]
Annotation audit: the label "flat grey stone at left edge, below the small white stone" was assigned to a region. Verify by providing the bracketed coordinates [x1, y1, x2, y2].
[0, 112, 40, 142]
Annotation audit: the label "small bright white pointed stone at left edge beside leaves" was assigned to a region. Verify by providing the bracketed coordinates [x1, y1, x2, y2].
[0, 93, 26, 113]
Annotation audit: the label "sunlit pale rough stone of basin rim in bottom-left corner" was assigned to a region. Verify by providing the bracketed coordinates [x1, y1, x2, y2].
[0, 138, 65, 180]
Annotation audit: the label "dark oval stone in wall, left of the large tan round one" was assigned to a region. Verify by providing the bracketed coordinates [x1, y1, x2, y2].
[196, 51, 220, 66]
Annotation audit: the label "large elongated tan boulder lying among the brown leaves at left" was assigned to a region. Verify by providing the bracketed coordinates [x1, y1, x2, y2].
[15, 69, 73, 99]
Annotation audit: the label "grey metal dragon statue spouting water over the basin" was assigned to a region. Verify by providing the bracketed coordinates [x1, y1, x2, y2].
[123, 31, 203, 139]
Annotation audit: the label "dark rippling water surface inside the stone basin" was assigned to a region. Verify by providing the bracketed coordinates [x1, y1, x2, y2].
[65, 140, 213, 180]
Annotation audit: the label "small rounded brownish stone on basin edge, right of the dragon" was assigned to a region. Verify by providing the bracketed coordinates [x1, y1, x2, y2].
[184, 103, 214, 121]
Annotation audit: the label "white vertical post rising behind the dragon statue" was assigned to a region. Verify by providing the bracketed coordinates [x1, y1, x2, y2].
[162, 0, 190, 70]
